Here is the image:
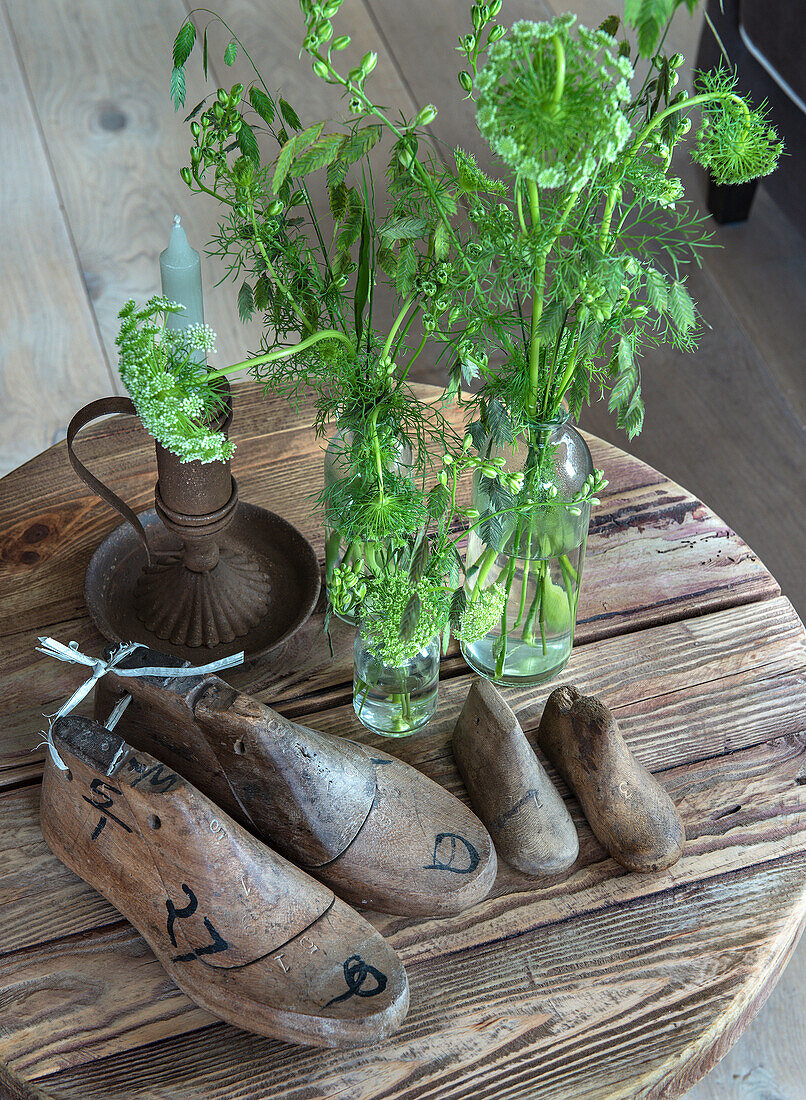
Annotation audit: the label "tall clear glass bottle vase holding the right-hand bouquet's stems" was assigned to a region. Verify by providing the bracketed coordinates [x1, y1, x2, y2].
[462, 417, 594, 684]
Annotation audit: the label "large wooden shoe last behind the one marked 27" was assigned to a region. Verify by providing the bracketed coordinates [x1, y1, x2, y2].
[96, 649, 497, 916]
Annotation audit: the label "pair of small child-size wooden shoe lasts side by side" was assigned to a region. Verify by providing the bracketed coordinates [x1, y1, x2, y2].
[453, 680, 685, 876]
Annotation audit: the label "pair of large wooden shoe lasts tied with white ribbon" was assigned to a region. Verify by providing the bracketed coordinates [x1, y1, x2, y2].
[41, 649, 496, 1046]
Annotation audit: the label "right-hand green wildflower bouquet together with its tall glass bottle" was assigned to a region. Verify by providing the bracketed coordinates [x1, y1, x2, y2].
[441, 0, 782, 683]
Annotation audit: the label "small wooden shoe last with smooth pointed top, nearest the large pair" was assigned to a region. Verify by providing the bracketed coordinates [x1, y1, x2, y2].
[453, 680, 579, 876]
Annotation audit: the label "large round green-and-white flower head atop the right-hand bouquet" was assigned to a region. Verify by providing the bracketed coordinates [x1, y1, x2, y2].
[476, 14, 632, 189]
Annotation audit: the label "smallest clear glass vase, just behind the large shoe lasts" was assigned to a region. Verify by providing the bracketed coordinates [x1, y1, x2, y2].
[353, 630, 440, 737]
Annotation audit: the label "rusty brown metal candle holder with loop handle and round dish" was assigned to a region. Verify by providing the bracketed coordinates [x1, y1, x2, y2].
[67, 388, 320, 660]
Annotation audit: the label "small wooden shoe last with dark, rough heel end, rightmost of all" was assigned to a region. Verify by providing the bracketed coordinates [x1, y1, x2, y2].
[538, 686, 685, 871]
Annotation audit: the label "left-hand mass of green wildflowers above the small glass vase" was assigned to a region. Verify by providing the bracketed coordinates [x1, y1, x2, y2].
[172, 0, 519, 661]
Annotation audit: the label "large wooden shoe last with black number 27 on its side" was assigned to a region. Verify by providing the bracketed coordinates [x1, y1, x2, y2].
[41, 717, 409, 1046]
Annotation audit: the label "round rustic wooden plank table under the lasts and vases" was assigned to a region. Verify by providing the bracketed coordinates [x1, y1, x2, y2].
[0, 385, 806, 1100]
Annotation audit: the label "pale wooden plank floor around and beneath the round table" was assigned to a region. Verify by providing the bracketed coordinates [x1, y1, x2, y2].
[0, 0, 806, 1100]
